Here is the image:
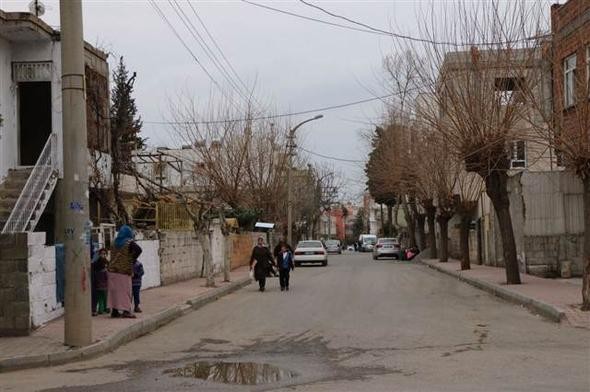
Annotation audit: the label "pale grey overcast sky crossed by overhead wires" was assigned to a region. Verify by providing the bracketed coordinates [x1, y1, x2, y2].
[0, 0, 454, 202]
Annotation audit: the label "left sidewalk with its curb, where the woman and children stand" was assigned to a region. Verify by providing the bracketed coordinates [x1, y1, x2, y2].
[0, 267, 250, 371]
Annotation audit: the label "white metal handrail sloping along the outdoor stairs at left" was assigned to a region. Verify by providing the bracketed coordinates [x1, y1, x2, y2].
[2, 133, 58, 233]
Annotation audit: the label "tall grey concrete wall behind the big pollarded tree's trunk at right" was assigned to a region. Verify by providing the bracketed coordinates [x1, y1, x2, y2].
[479, 171, 584, 276]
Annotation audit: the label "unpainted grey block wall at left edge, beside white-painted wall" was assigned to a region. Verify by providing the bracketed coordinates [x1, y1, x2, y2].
[0, 233, 31, 336]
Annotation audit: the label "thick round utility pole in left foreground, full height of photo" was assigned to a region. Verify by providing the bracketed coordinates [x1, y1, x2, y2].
[59, 0, 92, 347]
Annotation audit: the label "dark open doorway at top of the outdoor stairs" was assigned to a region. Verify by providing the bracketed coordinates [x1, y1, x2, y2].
[18, 82, 51, 166]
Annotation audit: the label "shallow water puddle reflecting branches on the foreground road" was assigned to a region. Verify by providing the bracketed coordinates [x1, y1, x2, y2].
[164, 361, 297, 385]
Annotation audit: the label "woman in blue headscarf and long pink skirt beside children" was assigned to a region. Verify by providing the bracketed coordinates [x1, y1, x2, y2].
[107, 225, 141, 318]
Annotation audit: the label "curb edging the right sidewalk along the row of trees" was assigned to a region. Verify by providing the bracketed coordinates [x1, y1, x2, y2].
[417, 257, 565, 323]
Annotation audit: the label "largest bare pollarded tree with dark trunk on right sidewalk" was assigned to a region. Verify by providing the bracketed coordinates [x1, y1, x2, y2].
[404, 0, 542, 284]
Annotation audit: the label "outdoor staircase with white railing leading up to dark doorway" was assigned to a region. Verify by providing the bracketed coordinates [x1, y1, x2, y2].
[0, 133, 59, 233]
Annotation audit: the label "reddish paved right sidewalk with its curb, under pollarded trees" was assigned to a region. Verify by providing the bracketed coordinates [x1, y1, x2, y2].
[418, 258, 590, 329]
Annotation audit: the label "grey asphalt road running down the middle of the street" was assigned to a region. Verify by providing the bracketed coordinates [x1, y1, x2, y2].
[0, 254, 590, 392]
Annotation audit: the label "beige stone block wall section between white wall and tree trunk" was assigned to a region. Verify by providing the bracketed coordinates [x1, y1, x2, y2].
[160, 231, 203, 285]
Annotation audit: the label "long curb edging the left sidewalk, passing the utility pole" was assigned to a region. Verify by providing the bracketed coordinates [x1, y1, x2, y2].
[0, 277, 252, 372]
